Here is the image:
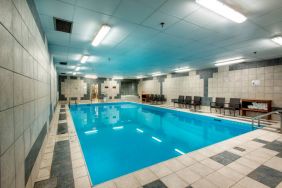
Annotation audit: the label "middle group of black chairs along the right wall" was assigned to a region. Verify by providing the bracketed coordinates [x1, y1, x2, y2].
[171, 95, 202, 110]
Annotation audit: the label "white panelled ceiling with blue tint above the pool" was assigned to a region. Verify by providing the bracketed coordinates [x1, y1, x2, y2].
[35, 0, 282, 77]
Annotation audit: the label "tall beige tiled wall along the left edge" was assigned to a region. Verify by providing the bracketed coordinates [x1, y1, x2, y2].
[0, 0, 56, 188]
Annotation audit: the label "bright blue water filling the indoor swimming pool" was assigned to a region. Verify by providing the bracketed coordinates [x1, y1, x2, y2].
[71, 103, 253, 185]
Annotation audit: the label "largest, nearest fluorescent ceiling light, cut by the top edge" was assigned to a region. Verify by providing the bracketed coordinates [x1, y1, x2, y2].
[196, 0, 247, 23]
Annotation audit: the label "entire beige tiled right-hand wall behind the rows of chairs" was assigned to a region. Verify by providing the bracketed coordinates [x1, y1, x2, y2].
[138, 58, 282, 108]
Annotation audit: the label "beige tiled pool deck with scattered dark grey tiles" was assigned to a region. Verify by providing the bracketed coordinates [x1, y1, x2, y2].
[35, 105, 282, 188]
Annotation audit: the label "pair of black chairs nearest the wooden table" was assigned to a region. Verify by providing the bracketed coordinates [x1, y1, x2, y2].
[210, 97, 241, 116]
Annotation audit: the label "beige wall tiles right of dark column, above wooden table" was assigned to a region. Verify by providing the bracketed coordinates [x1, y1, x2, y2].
[208, 65, 282, 108]
